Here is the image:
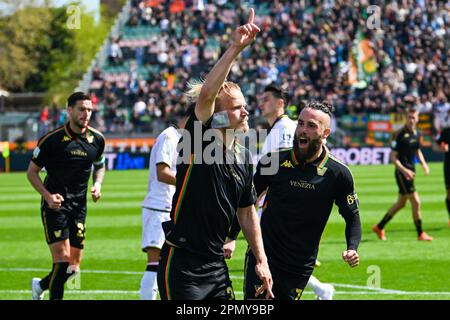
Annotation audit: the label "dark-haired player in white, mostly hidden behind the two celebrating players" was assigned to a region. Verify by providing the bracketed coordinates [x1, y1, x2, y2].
[228, 84, 335, 300]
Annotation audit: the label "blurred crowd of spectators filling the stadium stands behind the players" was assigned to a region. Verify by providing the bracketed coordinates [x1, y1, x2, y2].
[65, 0, 450, 133]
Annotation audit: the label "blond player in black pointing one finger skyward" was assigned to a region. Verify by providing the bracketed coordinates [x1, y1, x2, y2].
[158, 9, 273, 300]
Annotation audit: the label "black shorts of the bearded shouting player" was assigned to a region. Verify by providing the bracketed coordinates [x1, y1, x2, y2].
[244, 250, 311, 300]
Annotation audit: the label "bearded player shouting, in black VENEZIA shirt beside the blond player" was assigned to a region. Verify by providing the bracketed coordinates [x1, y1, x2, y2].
[244, 102, 361, 300]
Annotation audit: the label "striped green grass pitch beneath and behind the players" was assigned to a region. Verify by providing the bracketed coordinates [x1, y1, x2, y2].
[0, 163, 450, 300]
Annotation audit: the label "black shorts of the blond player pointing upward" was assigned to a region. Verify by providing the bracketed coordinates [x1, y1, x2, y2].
[158, 243, 235, 300]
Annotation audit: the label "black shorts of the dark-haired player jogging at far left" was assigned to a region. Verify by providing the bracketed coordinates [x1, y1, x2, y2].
[41, 201, 86, 249]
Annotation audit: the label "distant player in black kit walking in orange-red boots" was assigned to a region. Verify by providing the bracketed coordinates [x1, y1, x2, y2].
[372, 108, 433, 241]
